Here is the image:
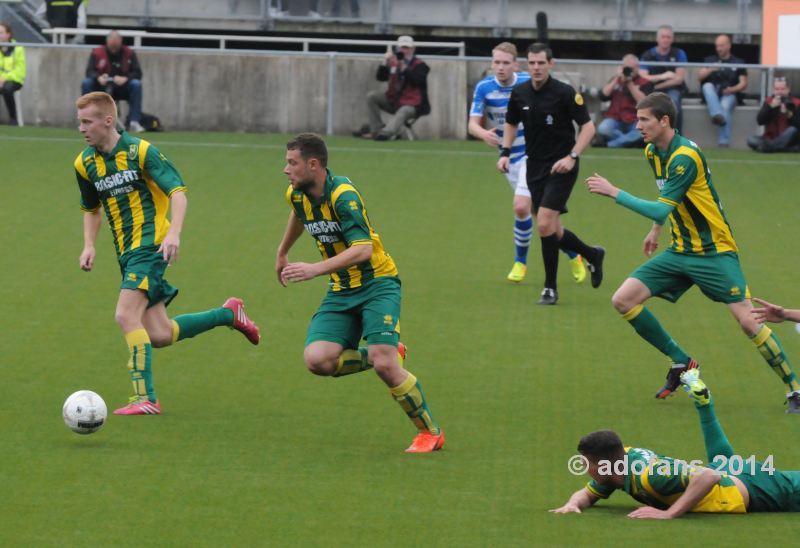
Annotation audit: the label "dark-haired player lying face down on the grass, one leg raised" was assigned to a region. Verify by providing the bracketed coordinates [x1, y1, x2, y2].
[551, 369, 800, 519]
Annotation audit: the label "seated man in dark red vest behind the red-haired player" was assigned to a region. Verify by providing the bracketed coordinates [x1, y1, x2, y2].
[82, 30, 144, 133]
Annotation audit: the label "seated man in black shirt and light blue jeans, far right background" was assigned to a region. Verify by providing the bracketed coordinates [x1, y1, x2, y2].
[697, 34, 747, 148]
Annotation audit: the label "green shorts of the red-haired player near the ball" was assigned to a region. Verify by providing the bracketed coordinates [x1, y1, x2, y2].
[119, 246, 178, 308]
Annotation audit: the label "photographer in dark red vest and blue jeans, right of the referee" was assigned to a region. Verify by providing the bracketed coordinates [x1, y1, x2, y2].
[597, 53, 653, 148]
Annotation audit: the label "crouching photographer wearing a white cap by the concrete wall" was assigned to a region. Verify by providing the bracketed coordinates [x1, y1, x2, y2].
[353, 36, 431, 141]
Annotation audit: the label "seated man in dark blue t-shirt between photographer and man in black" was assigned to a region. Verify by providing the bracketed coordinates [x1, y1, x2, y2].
[641, 25, 688, 131]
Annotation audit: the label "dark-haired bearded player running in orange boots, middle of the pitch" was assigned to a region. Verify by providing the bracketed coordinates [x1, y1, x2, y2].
[275, 133, 444, 453]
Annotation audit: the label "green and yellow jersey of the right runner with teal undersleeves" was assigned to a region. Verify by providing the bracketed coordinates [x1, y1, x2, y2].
[645, 132, 737, 255]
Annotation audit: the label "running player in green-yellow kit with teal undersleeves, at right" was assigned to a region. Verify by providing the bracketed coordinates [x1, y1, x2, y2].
[586, 93, 800, 413]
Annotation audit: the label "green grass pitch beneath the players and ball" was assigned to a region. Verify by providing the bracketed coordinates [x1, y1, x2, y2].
[0, 128, 800, 546]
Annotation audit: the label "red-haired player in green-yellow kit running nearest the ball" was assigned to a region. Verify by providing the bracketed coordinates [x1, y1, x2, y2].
[74, 92, 260, 415]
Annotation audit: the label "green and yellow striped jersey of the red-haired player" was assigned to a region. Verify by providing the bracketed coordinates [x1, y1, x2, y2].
[75, 132, 186, 257]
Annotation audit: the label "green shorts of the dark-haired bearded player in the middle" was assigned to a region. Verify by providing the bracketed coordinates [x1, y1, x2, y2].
[306, 276, 400, 348]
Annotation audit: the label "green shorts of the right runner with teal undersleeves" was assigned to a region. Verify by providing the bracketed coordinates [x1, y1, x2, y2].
[631, 251, 750, 303]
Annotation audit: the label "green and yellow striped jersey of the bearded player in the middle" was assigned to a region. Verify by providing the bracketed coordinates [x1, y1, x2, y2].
[286, 169, 397, 291]
